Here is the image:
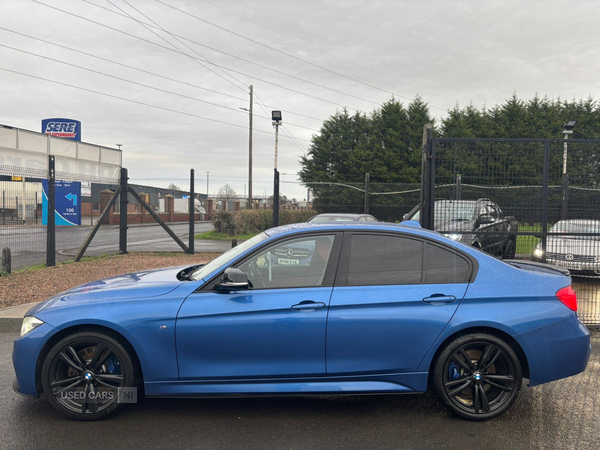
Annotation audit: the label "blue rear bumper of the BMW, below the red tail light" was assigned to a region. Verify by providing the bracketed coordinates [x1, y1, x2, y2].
[513, 313, 592, 386]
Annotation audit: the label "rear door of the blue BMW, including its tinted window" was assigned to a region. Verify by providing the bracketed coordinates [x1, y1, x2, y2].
[327, 232, 476, 375]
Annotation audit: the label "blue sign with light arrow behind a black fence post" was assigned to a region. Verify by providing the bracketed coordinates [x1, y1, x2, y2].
[42, 180, 81, 225]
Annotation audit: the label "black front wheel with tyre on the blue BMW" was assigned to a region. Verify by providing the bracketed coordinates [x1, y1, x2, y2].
[41, 330, 137, 420]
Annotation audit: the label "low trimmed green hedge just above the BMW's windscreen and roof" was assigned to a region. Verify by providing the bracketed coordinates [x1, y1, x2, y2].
[212, 209, 317, 236]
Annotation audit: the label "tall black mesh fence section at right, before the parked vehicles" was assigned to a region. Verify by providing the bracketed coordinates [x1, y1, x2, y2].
[420, 133, 600, 325]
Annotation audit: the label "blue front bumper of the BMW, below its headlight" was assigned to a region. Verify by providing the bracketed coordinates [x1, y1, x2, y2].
[12, 323, 56, 397]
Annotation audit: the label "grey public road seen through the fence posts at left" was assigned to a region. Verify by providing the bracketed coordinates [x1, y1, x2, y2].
[0, 222, 220, 270]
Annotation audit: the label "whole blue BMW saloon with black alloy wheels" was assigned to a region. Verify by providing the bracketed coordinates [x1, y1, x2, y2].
[13, 223, 591, 420]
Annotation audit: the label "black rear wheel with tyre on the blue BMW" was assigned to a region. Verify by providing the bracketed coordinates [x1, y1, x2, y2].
[430, 334, 523, 420]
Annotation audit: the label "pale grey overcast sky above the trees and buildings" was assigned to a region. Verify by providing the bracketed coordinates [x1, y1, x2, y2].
[0, 0, 600, 185]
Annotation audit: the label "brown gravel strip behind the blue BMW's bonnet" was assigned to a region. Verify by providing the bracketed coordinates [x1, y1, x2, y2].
[0, 253, 219, 309]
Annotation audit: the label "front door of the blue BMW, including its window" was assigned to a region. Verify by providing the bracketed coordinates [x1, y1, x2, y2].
[176, 233, 341, 379]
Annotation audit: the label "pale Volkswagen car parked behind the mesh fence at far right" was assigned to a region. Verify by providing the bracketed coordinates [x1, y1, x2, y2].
[532, 219, 600, 275]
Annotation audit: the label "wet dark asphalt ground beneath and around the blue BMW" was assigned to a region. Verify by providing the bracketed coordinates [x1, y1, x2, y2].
[0, 333, 600, 450]
